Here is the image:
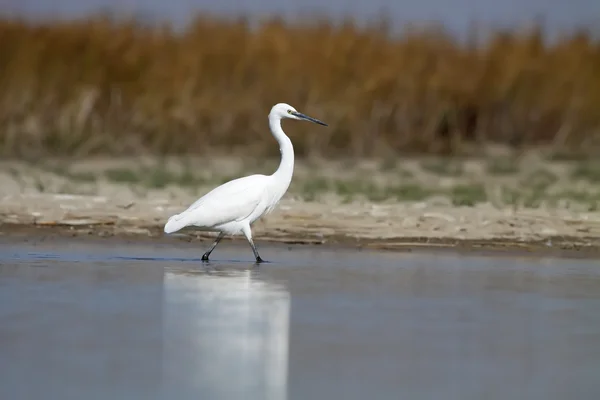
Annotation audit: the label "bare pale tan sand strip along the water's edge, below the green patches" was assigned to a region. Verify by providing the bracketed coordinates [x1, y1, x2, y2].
[0, 194, 600, 255]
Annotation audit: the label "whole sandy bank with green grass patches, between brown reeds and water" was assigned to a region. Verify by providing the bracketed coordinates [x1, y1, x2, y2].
[0, 157, 600, 258]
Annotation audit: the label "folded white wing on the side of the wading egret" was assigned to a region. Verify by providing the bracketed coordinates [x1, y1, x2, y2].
[178, 175, 268, 227]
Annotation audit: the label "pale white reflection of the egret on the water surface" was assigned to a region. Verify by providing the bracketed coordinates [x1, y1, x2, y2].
[163, 264, 290, 400]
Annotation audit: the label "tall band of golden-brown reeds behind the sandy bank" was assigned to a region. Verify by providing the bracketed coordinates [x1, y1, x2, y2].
[0, 16, 600, 157]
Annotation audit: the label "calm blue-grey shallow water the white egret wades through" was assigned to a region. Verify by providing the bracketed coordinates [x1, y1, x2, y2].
[0, 239, 600, 400]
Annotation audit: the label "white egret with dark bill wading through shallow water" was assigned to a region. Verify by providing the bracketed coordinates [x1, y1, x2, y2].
[164, 103, 327, 263]
